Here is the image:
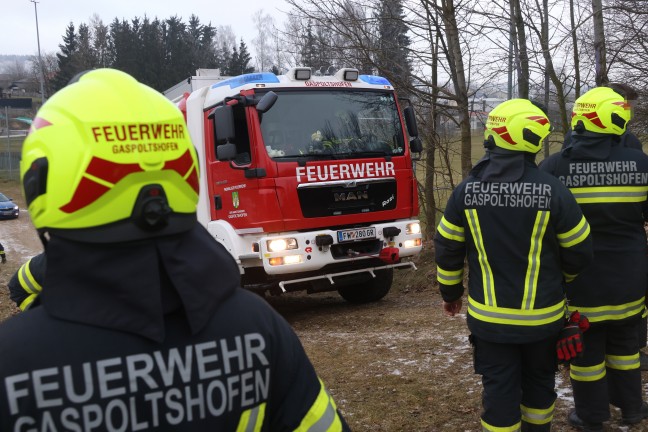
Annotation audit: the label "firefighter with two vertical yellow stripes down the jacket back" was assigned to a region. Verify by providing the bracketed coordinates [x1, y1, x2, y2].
[435, 99, 592, 431]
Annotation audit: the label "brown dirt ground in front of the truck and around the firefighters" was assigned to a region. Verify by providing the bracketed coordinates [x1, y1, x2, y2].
[0, 180, 648, 432]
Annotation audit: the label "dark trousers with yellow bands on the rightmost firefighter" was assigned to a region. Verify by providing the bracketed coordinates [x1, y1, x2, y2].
[569, 319, 643, 423]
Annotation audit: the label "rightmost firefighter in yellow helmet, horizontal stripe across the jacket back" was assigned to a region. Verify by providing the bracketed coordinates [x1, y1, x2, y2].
[541, 87, 648, 431]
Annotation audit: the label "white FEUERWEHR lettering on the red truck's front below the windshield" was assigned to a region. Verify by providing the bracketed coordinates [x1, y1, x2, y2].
[295, 161, 396, 183]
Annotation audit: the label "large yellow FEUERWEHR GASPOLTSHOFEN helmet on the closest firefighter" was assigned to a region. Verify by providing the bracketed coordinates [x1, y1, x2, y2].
[20, 69, 199, 243]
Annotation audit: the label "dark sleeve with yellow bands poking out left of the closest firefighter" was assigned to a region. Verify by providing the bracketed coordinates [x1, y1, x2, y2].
[7, 252, 47, 311]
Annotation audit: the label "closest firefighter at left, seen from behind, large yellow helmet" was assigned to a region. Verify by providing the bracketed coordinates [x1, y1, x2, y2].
[0, 69, 348, 431]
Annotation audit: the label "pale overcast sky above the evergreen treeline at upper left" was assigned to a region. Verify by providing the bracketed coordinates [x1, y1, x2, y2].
[0, 0, 288, 55]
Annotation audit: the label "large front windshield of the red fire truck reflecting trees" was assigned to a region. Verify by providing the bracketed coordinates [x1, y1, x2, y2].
[261, 89, 405, 159]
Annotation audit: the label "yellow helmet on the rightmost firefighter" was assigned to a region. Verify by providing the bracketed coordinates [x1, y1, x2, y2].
[571, 87, 632, 135]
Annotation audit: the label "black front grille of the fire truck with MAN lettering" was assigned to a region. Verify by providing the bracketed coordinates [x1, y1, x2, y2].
[297, 179, 397, 218]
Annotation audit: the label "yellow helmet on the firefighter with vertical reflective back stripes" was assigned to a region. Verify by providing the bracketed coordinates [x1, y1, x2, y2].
[484, 99, 551, 154]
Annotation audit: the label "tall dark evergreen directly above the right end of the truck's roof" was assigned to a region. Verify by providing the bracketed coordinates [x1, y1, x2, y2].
[376, 0, 412, 96]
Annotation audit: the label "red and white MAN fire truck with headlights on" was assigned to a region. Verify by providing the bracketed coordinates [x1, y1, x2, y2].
[165, 67, 422, 303]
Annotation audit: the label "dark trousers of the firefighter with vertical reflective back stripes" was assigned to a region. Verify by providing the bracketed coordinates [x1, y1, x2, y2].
[471, 335, 558, 432]
